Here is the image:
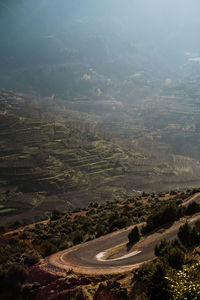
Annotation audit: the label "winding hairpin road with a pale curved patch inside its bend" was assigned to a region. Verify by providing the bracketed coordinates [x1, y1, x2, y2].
[45, 193, 200, 274]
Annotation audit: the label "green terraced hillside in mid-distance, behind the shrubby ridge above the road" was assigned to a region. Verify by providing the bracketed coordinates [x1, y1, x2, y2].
[0, 90, 200, 223]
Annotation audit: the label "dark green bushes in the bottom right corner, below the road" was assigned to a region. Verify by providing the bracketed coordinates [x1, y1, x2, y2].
[135, 222, 200, 300]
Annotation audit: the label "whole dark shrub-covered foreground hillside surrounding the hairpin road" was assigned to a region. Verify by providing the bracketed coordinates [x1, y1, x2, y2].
[0, 190, 200, 300]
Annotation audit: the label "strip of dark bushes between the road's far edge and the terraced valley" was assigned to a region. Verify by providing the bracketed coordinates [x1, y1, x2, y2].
[0, 191, 199, 299]
